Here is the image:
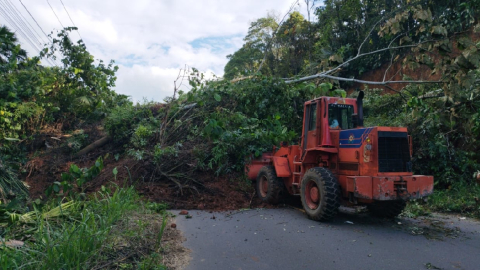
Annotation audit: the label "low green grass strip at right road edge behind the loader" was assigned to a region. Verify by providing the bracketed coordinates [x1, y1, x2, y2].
[403, 182, 480, 219]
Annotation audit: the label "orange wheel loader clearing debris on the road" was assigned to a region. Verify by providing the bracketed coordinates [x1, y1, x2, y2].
[245, 92, 433, 221]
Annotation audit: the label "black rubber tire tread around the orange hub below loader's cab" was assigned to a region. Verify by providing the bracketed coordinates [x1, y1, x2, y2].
[301, 167, 341, 221]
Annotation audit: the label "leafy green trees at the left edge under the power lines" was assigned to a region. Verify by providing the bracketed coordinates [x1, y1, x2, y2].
[0, 27, 121, 184]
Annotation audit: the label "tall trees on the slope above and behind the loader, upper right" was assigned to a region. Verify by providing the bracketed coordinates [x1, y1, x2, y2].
[220, 0, 480, 186]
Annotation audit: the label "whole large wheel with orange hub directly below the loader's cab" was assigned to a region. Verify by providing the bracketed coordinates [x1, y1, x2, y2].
[300, 167, 341, 221]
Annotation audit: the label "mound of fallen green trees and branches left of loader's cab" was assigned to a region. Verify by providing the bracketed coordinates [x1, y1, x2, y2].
[110, 65, 346, 176]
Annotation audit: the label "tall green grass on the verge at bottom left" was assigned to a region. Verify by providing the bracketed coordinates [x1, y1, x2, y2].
[0, 188, 172, 270]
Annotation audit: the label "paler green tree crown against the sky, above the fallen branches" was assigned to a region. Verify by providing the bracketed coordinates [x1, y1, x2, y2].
[224, 11, 315, 79]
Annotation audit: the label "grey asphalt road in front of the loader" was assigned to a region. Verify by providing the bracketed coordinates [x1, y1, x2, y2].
[176, 208, 480, 270]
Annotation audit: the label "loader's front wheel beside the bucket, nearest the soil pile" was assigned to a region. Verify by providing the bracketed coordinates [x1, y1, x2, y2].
[255, 166, 286, 204]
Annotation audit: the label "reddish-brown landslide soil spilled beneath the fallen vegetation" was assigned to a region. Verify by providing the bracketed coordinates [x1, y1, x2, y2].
[23, 123, 266, 210]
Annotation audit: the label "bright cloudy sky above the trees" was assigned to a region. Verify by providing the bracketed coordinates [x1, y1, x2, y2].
[0, 0, 316, 102]
